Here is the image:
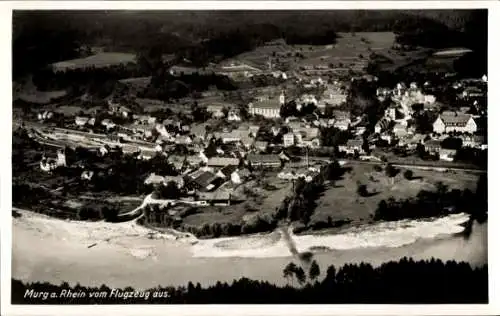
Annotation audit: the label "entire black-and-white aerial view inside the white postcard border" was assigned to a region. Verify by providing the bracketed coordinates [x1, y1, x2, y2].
[7, 9, 490, 305]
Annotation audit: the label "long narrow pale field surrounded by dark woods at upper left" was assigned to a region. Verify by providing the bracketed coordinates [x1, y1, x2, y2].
[52, 53, 135, 71]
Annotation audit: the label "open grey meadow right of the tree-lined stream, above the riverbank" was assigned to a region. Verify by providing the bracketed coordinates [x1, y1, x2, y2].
[311, 164, 477, 224]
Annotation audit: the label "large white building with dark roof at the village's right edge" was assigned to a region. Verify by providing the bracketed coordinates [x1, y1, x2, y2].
[432, 112, 477, 134]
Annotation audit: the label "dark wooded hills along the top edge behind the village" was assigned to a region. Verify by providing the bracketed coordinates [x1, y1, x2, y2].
[12, 10, 487, 78]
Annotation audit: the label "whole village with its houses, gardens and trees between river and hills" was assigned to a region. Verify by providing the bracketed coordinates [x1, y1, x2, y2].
[15, 29, 487, 236]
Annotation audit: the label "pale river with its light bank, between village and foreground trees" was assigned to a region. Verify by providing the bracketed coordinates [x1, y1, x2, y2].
[12, 211, 487, 288]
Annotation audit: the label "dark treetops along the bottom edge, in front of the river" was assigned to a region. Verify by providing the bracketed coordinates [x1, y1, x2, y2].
[12, 257, 488, 304]
